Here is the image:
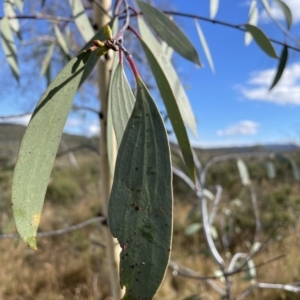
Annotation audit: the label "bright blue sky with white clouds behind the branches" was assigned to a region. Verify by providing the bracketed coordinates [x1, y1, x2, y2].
[0, 0, 300, 147]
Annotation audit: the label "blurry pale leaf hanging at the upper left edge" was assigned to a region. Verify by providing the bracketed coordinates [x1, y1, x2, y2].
[1, 17, 20, 81]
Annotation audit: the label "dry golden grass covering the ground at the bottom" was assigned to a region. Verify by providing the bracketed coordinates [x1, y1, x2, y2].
[0, 157, 300, 300]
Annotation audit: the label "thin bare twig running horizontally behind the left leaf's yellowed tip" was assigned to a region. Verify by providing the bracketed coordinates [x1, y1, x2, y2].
[0, 217, 106, 239]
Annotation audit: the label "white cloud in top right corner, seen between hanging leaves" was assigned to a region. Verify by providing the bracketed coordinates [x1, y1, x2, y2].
[259, 0, 300, 24]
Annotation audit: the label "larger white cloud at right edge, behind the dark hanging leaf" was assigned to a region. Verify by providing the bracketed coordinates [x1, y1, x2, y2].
[237, 62, 300, 105]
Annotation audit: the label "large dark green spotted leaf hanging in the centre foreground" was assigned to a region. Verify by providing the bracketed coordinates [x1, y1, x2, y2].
[108, 78, 173, 300]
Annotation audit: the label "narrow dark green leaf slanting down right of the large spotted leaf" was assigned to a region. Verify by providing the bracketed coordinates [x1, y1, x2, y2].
[138, 18, 196, 182]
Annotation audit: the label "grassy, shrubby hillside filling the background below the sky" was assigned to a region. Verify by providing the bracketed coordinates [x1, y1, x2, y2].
[0, 124, 300, 300]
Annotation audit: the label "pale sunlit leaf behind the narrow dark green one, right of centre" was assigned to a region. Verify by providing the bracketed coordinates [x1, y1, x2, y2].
[138, 17, 198, 137]
